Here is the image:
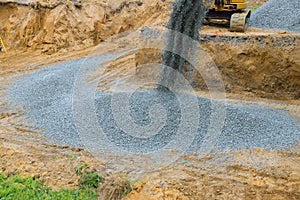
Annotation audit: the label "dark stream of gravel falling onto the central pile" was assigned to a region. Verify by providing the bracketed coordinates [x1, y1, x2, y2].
[159, 0, 206, 88]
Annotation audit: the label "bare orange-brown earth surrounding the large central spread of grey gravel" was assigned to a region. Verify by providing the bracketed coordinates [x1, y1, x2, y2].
[0, 0, 300, 200]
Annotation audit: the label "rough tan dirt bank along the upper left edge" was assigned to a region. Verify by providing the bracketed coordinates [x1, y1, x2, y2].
[0, 0, 169, 53]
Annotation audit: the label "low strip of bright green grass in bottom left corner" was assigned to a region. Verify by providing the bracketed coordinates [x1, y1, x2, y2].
[0, 173, 97, 200]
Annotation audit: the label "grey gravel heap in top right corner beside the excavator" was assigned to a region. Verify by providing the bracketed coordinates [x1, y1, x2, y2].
[250, 0, 300, 32]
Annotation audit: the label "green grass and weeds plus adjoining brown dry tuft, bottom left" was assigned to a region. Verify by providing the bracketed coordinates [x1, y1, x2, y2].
[0, 162, 134, 200]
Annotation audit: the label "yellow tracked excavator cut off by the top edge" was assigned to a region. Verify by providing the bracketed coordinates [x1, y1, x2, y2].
[204, 0, 251, 32]
